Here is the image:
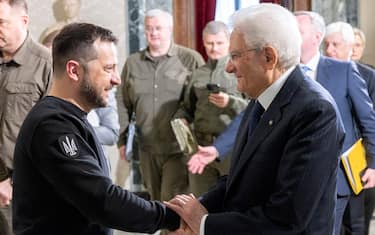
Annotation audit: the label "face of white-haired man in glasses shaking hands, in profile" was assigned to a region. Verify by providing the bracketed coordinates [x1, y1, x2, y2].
[226, 30, 268, 98]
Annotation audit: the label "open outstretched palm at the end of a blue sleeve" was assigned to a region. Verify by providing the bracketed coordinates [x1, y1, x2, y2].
[188, 146, 219, 174]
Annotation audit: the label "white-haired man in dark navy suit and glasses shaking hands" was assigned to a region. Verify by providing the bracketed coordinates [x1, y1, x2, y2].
[167, 4, 344, 235]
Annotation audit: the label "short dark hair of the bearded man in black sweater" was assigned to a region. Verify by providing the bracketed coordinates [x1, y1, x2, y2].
[52, 23, 117, 74]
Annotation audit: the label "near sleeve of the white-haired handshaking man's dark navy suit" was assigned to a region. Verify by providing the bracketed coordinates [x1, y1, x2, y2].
[202, 98, 343, 235]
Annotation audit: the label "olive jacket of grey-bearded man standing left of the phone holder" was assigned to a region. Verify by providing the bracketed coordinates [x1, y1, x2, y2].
[118, 44, 204, 154]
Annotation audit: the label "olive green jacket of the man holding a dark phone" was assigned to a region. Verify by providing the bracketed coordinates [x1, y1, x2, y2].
[174, 57, 247, 141]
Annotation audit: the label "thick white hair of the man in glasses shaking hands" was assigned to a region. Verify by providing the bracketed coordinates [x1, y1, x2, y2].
[231, 3, 302, 69]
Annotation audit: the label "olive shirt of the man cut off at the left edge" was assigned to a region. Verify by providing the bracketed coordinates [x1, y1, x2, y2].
[0, 34, 52, 181]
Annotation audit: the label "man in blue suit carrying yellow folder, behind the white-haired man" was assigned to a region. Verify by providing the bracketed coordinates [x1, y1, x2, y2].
[295, 12, 375, 234]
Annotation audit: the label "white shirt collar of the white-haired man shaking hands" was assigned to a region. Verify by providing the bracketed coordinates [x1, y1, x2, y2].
[257, 66, 296, 110]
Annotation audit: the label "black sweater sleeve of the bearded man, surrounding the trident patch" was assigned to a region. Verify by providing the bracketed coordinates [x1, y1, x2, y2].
[31, 117, 179, 233]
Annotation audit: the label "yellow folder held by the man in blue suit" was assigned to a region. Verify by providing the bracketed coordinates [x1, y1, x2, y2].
[341, 138, 367, 195]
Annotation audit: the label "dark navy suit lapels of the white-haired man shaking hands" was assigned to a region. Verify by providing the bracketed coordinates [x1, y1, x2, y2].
[227, 66, 304, 189]
